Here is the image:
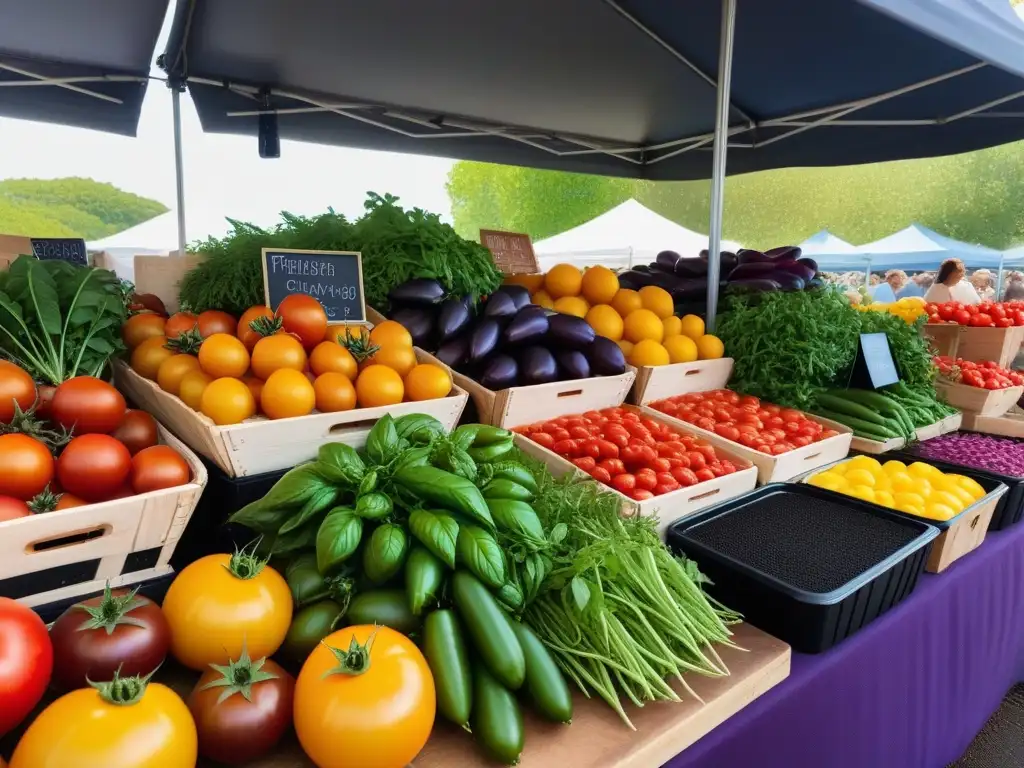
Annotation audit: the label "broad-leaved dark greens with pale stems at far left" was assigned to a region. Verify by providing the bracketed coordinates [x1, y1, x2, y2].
[0, 256, 128, 385]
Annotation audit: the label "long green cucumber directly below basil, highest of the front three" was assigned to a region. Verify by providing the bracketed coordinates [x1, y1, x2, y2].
[452, 570, 526, 690]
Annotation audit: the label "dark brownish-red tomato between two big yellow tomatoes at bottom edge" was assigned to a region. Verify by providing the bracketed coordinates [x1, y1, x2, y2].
[187, 649, 295, 765]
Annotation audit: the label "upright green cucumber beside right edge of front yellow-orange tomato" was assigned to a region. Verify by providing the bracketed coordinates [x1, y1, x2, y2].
[423, 609, 473, 727]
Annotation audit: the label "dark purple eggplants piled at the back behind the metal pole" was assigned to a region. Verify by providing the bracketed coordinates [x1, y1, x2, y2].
[618, 246, 821, 314]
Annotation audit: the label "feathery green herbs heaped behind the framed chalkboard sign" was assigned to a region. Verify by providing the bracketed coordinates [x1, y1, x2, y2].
[180, 193, 502, 314]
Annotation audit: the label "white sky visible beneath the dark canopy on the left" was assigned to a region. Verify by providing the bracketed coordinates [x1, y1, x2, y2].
[0, 5, 453, 246]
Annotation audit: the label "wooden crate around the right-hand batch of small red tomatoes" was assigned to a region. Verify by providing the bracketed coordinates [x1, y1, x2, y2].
[642, 406, 853, 485]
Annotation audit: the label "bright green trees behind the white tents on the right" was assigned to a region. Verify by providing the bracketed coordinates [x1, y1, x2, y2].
[447, 137, 1024, 248]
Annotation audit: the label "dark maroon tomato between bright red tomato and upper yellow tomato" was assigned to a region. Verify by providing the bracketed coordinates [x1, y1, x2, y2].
[50, 587, 171, 689]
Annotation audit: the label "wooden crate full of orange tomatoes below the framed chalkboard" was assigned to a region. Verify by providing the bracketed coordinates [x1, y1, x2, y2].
[116, 294, 467, 477]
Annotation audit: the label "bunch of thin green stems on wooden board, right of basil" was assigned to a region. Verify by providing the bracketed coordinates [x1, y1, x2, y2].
[519, 458, 739, 727]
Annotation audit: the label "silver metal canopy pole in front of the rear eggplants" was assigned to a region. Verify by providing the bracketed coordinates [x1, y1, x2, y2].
[708, 0, 736, 332]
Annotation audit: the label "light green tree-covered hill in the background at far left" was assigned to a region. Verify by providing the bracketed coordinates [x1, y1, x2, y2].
[0, 178, 167, 240]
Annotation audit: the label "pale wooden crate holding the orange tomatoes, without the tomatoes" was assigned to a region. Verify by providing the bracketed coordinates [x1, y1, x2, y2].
[114, 349, 468, 477]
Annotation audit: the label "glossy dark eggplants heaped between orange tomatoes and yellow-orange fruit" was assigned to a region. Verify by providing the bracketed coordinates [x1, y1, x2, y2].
[388, 279, 626, 390]
